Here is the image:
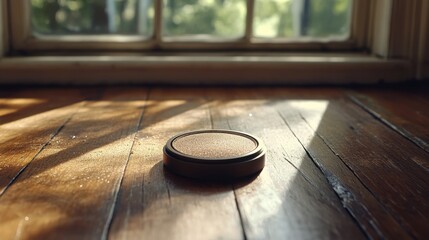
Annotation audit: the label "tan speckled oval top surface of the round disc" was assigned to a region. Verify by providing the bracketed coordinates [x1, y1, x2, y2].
[172, 132, 258, 160]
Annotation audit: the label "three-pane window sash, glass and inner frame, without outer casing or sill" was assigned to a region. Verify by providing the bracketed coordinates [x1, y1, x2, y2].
[10, 0, 358, 50]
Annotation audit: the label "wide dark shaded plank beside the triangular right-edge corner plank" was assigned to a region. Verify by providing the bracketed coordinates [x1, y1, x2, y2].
[288, 98, 429, 239]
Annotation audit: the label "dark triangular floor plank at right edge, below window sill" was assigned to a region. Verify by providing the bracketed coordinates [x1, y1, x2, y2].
[350, 89, 429, 152]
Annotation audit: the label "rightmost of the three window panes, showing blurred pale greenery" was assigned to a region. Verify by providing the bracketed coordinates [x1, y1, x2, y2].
[253, 0, 352, 39]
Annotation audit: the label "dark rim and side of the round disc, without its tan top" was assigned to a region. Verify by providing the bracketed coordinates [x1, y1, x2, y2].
[164, 130, 265, 178]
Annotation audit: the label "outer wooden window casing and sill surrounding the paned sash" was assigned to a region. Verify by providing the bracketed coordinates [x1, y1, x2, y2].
[0, 0, 429, 85]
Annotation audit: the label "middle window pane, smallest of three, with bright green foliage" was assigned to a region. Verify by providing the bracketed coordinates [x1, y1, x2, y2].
[163, 0, 246, 38]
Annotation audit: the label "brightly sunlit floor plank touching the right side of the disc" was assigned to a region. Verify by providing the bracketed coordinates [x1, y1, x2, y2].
[208, 90, 364, 239]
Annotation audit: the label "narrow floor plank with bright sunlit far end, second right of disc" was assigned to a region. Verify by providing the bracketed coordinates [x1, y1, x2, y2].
[276, 100, 410, 239]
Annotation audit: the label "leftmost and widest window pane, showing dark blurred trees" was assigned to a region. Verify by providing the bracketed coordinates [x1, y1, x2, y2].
[31, 0, 154, 36]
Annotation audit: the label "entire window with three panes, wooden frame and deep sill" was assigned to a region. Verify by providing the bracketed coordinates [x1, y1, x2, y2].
[0, 0, 429, 84]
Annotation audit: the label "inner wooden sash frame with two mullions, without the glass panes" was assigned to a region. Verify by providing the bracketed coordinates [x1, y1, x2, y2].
[8, 0, 364, 52]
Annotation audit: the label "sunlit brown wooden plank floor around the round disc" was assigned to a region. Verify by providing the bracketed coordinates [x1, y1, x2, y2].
[0, 87, 429, 240]
